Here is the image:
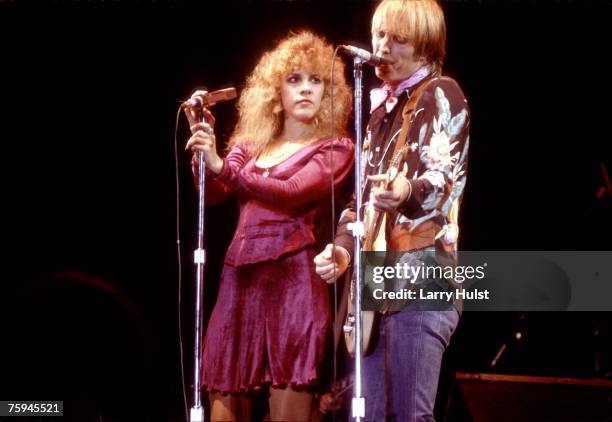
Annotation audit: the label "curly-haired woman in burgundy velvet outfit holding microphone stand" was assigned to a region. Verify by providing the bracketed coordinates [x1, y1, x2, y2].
[187, 32, 353, 421]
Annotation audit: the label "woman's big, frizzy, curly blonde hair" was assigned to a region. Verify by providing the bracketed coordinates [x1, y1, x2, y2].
[228, 31, 352, 156]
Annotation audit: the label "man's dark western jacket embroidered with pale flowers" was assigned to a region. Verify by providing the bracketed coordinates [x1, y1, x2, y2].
[336, 77, 470, 270]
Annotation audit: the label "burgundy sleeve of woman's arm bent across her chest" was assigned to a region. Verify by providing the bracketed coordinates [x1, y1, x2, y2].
[217, 139, 353, 209]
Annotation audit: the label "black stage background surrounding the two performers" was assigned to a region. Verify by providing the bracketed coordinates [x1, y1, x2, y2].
[0, 0, 612, 420]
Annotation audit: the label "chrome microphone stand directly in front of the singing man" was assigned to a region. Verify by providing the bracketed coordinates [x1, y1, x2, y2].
[351, 56, 365, 422]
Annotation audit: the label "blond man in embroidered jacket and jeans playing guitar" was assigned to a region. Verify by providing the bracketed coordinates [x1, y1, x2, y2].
[315, 0, 469, 421]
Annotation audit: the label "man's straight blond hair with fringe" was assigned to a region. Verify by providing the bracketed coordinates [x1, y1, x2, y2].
[372, 0, 446, 74]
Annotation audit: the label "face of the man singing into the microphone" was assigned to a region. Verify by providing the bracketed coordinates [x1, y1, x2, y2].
[372, 24, 426, 87]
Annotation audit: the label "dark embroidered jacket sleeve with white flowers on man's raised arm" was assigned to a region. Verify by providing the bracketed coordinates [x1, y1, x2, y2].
[398, 79, 469, 218]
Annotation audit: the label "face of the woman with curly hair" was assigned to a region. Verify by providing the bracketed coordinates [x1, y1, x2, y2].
[281, 69, 325, 123]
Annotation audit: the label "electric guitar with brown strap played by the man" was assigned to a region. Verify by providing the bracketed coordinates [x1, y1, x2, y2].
[343, 145, 408, 356]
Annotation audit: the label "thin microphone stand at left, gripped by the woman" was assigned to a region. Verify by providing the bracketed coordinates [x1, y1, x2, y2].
[189, 116, 206, 422]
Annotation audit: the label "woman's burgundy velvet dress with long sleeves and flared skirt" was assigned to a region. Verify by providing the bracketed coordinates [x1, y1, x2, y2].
[202, 139, 353, 394]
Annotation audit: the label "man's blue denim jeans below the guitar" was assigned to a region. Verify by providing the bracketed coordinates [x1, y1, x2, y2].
[363, 307, 460, 422]
